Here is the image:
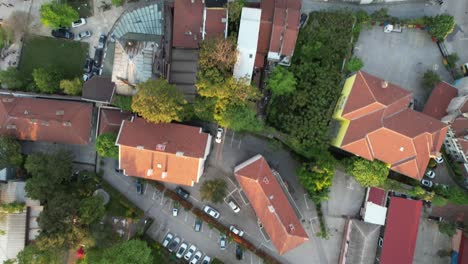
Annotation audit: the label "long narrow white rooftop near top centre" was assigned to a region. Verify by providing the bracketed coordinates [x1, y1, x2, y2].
[234, 7, 262, 84]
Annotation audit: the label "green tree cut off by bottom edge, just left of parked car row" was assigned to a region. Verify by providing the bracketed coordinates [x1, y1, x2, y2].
[89, 239, 154, 264]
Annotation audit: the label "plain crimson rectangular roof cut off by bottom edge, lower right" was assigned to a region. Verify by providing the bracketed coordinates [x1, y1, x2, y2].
[380, 197, 422, 264]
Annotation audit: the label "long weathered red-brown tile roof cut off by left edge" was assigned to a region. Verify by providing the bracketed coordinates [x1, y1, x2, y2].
[0, 96, 93, 145]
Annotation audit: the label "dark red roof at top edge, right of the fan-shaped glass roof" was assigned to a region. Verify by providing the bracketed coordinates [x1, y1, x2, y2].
[172, 0, 203, 49]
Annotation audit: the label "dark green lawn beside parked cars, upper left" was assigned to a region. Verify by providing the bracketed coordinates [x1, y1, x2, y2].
[19, 36, 89, 79]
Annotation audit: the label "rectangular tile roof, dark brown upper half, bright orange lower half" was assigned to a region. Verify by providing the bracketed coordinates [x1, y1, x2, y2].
[116, 118, 211, 186]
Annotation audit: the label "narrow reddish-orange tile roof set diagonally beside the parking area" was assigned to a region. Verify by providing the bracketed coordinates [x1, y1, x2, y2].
[235, 155, 309, 255]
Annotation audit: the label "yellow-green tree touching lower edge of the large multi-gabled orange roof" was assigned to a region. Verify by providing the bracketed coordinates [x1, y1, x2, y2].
[347, 157, 389, 187]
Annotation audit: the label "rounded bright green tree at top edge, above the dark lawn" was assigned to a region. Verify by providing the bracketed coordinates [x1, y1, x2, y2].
[39, 0, 79, 29]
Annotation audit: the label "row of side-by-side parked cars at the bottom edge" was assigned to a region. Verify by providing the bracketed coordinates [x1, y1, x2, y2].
[162, 233, 211, 264]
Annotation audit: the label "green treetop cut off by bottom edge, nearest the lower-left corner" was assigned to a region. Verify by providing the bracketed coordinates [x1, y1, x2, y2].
[16, 244, 62, 264]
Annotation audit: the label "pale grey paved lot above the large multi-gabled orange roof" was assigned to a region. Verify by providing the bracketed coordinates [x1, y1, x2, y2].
[354, 26, 452, 110]
